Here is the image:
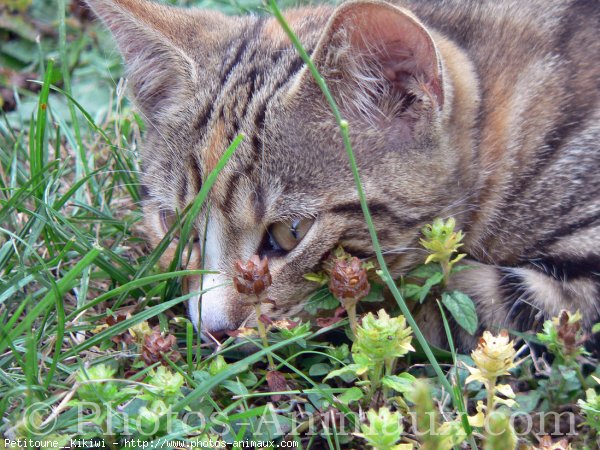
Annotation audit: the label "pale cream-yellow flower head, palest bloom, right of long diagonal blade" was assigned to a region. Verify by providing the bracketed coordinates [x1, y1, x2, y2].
[466, 330, 517, 385]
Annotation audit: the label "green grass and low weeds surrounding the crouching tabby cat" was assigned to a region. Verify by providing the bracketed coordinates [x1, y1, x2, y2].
[0, 0, 600, 449]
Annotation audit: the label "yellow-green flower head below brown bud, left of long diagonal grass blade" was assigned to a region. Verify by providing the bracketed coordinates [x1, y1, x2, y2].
[352, 309, 415, 361]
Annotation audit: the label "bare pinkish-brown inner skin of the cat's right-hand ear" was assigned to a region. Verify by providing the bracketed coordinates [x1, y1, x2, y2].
[342, 4, 443, 105]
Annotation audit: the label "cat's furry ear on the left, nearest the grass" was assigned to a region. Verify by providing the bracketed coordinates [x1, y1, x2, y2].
[86, 0, 227, 120]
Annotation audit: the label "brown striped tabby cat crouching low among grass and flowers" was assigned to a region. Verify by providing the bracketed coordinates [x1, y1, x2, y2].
[87, 0, 600, 351]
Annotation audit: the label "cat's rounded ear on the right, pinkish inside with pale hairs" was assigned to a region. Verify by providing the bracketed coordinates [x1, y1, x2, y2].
[313, 1, 444, 119]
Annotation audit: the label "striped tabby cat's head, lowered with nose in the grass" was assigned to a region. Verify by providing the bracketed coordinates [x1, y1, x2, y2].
[88, 0, 476, 338]
